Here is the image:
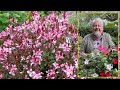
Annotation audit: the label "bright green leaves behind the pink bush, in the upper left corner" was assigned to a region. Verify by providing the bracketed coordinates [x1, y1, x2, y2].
[0, 11, 29, 32]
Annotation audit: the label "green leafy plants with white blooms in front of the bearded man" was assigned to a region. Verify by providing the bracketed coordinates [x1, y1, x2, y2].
[78, 47, 118, 77]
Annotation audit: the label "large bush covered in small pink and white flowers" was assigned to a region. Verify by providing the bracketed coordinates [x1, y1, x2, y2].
[0, 11, 78, 79]
